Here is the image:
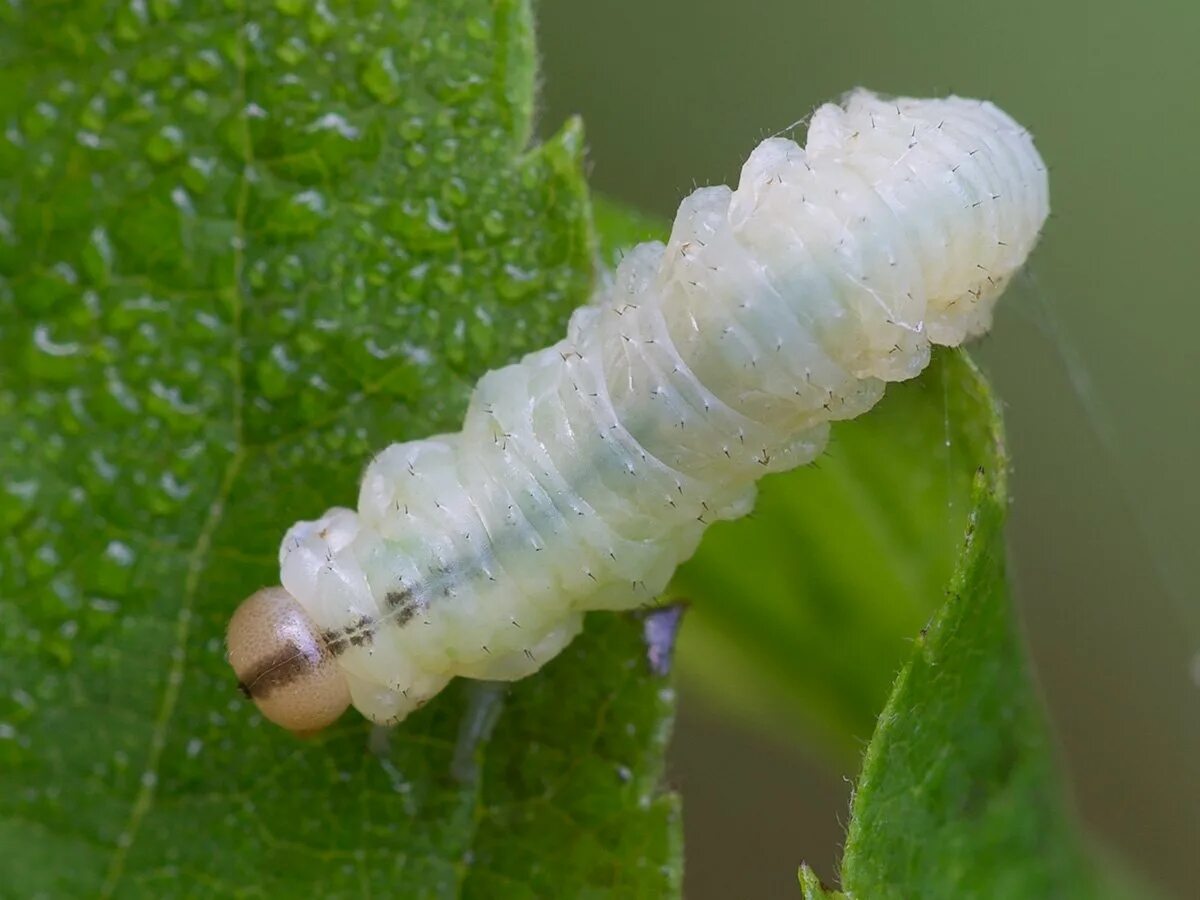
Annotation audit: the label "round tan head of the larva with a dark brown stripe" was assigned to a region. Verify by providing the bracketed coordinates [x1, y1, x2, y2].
[226, 587, 350, 734]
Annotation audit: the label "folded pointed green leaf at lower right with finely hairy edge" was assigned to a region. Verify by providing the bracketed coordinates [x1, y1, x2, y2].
[841, 354, 1118, 899]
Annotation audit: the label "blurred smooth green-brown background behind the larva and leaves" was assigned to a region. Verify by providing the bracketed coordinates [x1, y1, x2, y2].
[538, 0, 1200, 900]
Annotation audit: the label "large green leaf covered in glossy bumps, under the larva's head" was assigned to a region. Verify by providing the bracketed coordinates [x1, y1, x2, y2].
[0, 0, 680, 898]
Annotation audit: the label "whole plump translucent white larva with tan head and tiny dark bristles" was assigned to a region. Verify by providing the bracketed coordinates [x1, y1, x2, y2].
[227, 89, 1049, 733]
